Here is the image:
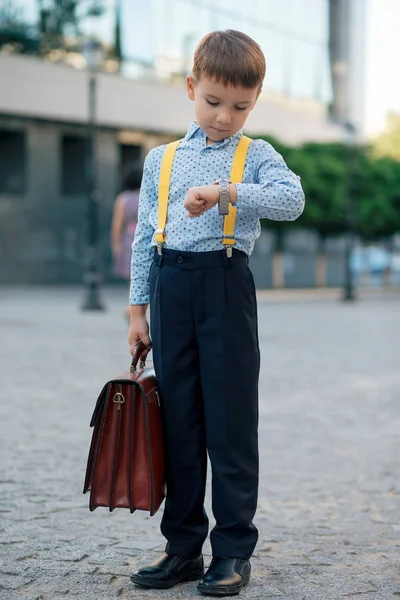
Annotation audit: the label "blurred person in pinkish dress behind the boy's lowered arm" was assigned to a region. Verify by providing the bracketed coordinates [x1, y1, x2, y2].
[111, 166, 143, 318]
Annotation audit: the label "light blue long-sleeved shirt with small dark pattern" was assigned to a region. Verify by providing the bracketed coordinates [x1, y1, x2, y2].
[130, 122, 304, 304]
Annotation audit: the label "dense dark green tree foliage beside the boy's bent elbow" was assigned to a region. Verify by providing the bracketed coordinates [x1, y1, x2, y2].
[263, 135, 400, 240]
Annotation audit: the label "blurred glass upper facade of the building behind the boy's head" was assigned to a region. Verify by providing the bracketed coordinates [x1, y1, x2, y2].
[0, 0, 331, 103]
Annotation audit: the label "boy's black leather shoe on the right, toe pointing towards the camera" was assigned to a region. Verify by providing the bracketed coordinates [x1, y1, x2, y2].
[197, 556, 251, 596]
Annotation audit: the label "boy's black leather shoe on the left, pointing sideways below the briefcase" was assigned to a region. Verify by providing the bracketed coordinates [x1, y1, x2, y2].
[131, 552, 204, 590]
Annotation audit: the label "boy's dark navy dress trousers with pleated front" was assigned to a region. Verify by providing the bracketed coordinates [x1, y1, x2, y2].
[150, 249, 260, 558]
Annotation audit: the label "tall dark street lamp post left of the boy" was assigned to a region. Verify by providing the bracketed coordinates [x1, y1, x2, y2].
[82, 40, 104, 311]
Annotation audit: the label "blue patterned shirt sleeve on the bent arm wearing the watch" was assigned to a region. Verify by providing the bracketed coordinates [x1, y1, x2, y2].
[236, 140, 305, 221]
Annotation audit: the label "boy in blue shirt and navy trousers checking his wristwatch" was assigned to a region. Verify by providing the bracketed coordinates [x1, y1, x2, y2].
[128, 30, 304, 596]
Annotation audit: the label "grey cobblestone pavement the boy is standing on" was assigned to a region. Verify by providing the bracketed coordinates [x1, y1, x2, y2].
[0, 288, 400, 600]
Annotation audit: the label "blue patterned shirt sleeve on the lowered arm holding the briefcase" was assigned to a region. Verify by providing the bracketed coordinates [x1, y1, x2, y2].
[129, 150, 157, 304]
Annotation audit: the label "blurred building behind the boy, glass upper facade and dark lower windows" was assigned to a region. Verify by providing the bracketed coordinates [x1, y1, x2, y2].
[0, 0, 341, 283]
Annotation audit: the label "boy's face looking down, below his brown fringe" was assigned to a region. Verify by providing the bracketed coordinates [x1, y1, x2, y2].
[186, 75, 260, 142]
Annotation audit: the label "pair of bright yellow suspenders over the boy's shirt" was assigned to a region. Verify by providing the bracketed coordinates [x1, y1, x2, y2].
[155, 135, 252, 255]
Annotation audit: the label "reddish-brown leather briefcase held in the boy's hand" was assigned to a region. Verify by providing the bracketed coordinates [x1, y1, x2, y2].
[83, 343, 165, 515]
